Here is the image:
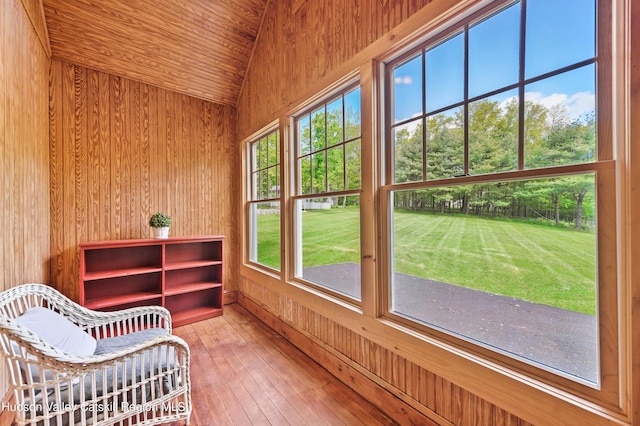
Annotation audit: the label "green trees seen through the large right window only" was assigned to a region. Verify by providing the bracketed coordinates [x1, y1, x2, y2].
[394, 99, 596, 229]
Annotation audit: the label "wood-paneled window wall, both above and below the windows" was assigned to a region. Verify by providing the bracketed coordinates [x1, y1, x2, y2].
[238, 0, 640, 426]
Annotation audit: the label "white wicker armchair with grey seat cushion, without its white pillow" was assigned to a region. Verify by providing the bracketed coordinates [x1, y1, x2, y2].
[0, 284, 191, 426]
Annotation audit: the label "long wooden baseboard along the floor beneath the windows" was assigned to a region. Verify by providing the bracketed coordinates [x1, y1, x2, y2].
[237, 292, 453, 426]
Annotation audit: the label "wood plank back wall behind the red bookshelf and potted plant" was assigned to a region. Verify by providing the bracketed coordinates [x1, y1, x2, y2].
[50, 60, 240, 300]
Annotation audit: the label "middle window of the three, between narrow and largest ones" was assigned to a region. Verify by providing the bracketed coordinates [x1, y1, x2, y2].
[294, 84, 361, 301]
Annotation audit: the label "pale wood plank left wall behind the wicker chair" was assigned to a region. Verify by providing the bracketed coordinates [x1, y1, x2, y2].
[0, 0, 50, 402]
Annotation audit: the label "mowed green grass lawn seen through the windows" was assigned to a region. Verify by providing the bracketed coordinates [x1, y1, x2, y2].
[259, 208, 596, 315]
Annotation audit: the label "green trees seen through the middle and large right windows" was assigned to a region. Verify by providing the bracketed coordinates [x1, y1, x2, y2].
[290, 94, 596, 229]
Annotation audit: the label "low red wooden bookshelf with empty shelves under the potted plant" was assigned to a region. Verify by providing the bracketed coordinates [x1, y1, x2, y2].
[80, 236, 224, 327]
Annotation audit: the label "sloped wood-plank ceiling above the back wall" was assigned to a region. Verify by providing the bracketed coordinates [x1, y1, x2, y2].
[42, 0, 268, 106]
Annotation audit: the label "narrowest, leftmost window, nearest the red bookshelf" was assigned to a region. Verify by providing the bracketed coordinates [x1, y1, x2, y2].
[247, 130, 281, 270]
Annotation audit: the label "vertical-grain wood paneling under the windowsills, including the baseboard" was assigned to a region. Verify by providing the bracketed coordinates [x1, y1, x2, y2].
[238, 279, 529, 426]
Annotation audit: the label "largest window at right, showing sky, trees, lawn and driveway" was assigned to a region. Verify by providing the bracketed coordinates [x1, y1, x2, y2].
[382, 0, 615, 388]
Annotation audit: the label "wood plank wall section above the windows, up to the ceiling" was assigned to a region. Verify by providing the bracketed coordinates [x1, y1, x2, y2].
[238, 0, 433, 138]
